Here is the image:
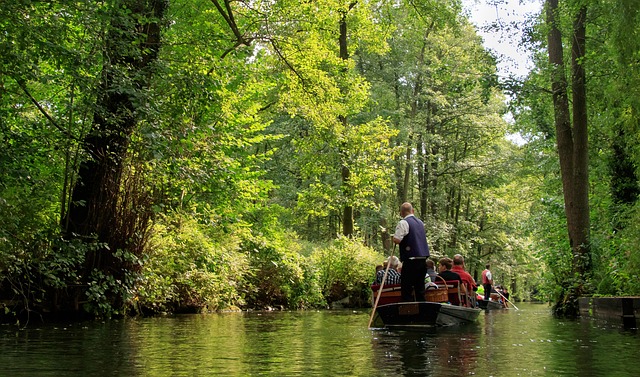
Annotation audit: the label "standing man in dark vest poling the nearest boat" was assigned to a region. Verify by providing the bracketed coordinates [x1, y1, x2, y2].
[393, 203, 429, 301]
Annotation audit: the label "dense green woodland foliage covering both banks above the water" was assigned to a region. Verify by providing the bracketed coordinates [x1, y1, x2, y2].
[0, 0, 640, 318]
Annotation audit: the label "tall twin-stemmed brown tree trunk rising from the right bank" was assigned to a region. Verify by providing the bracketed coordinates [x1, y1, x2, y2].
[547, 0, 590, 316]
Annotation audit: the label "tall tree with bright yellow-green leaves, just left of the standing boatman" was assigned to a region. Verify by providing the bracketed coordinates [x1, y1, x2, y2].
[260, 0, 392, 237]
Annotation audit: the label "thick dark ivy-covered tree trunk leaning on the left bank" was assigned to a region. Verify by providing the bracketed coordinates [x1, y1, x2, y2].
[62, 0, 168, 312]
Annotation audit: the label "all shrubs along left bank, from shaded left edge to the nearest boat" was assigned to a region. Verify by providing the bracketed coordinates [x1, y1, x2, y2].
[0, 210, 382, 322]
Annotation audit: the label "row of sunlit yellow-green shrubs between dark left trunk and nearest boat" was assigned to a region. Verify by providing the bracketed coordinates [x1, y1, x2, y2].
[132, 213, 381, 313]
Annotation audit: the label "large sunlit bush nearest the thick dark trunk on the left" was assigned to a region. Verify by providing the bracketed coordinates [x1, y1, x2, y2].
[134, 214, 248, 312]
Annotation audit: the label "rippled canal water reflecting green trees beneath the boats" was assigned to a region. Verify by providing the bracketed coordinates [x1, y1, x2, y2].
[0, 303, 640, 377]
